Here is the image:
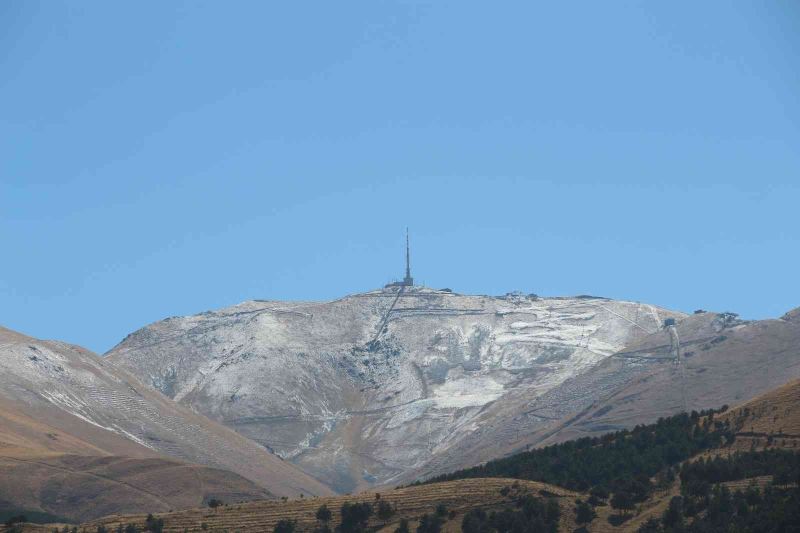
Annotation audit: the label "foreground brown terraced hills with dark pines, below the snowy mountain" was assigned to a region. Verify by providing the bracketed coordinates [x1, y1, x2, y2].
[78, 374, 800, 533]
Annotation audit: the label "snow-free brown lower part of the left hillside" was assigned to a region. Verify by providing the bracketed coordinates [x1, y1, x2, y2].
[0, 392, 271, 521]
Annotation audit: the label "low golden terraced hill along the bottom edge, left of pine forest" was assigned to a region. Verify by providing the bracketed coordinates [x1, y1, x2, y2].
[83, 478, 579, 533]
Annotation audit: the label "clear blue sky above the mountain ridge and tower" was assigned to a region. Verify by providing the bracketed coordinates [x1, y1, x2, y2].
[0, 0, 800, 352]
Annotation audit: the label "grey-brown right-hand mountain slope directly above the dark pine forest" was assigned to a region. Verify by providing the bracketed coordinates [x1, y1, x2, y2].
[401, 313, 800, 482]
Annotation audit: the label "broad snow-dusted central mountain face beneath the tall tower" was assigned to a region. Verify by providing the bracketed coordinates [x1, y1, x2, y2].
[108, 287, 684, 492]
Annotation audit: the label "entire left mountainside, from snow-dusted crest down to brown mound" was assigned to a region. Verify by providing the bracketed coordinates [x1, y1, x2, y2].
[0, 328, 330, 519]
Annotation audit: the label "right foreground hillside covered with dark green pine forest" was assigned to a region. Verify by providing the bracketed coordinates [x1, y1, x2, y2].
[422, 380, 800, 533]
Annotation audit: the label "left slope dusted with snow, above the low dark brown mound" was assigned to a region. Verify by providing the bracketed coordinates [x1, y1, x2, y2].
[0, 328, 330, 495]
